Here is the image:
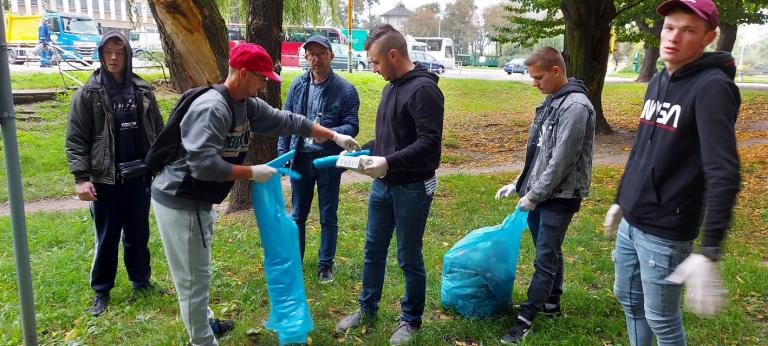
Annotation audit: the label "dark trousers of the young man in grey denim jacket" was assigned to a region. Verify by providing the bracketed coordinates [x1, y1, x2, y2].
[519, 208, 574, 322]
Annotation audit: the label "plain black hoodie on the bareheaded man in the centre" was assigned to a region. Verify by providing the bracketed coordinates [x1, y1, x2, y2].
[365, 64, 444, 186]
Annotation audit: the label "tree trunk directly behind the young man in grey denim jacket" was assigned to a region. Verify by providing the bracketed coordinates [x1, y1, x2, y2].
[560, 0, 616, 134]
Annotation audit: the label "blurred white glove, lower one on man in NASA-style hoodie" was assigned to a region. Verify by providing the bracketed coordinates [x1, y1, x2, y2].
[667, 254, 728, 317]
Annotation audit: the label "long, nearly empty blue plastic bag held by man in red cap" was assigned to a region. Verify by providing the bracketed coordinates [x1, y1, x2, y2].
[251, 150, 313, 345]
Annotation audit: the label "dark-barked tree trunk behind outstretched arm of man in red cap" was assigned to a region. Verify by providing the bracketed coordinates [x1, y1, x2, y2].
[227, 0, 289, 213]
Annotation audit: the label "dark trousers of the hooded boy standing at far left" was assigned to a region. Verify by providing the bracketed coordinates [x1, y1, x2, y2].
[91, 178, 151, 294]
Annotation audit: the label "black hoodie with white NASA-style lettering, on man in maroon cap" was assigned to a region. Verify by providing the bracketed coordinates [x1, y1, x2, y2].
[617, 52, 741, 247]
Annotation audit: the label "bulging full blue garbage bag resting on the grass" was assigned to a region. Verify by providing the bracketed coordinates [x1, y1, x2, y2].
[440, 209, 528, 317]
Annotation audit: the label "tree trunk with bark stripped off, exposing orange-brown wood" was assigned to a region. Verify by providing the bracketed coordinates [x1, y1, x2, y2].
[149, 0, 229, 92]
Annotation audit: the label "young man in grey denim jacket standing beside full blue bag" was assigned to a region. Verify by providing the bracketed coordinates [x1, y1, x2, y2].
[496, 47, 595, 344]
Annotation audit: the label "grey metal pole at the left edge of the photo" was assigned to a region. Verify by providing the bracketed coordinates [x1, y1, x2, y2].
[0, 6, 37, 345]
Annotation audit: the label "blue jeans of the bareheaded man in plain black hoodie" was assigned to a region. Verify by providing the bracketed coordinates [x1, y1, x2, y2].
[358, 179, 432, 325]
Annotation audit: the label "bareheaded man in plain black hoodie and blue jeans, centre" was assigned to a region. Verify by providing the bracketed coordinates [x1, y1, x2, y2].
[336, 24, 444, 345]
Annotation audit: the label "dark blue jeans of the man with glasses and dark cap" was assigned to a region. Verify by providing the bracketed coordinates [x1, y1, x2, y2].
[291, 152, 342, 269]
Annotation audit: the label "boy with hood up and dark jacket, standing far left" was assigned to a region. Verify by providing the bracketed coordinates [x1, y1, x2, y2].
[65, 32, 163, 316]
